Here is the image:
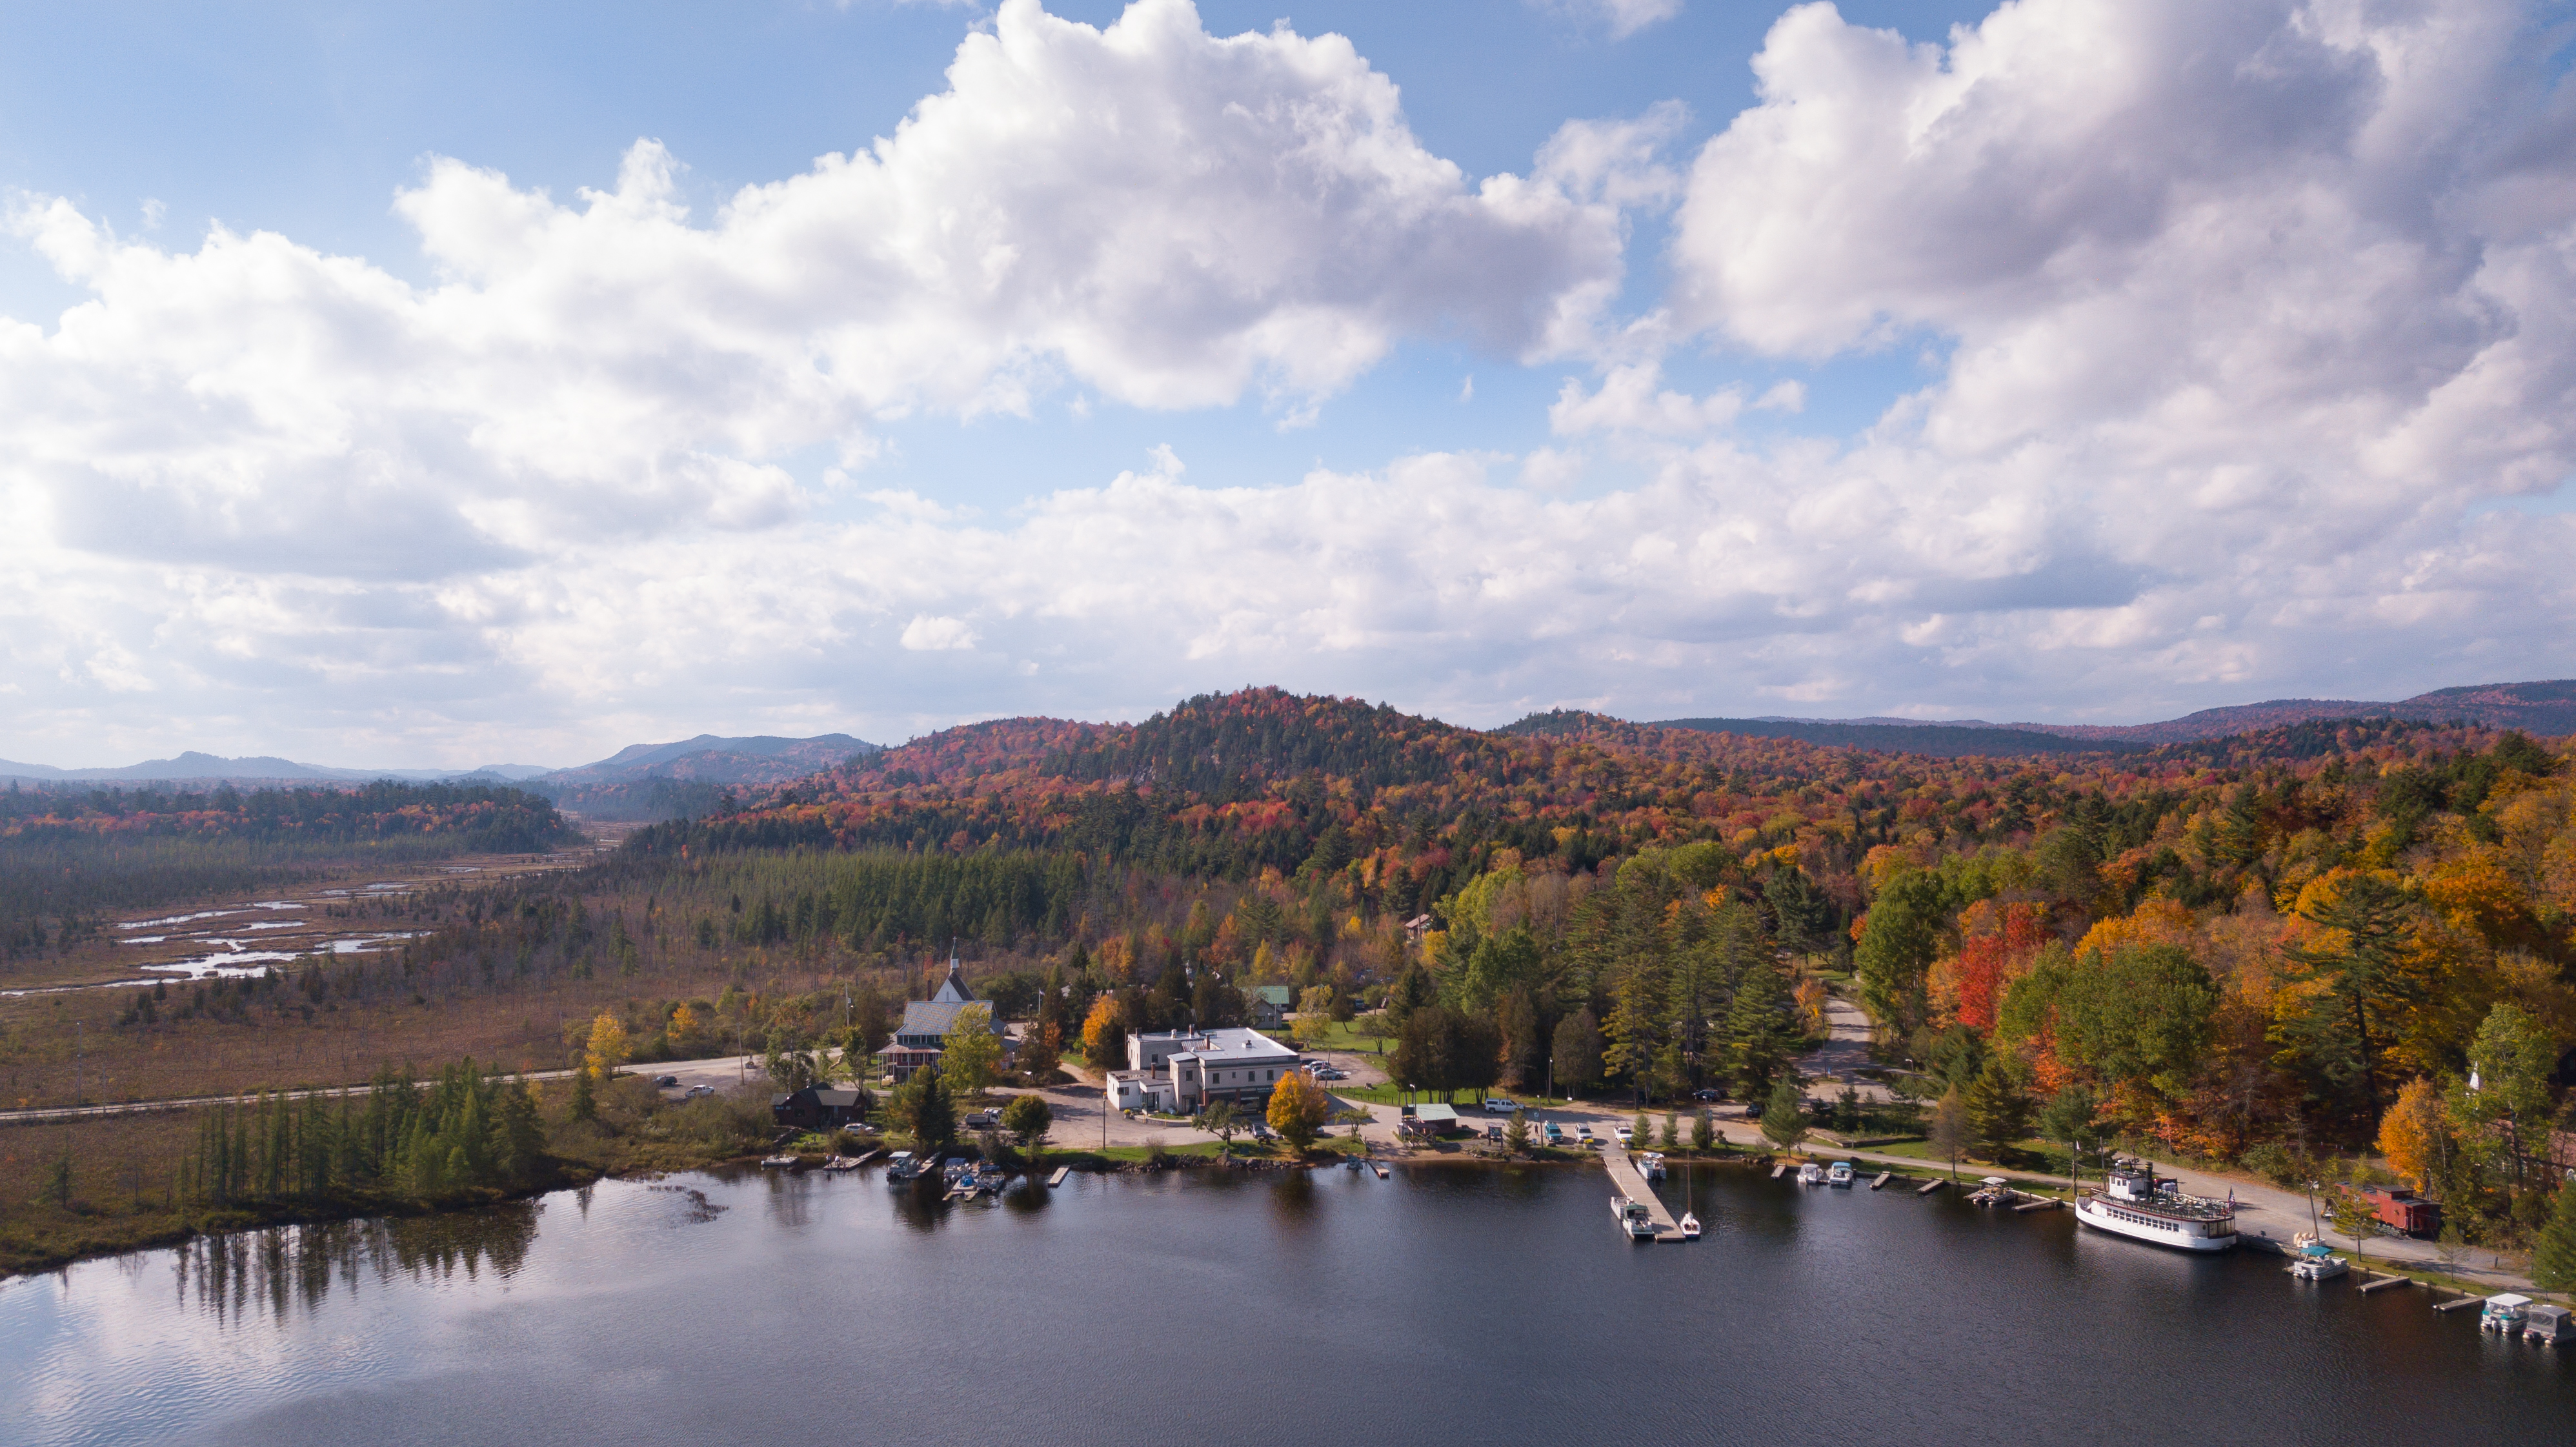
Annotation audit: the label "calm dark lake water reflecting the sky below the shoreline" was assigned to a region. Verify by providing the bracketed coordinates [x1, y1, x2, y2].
[0, 1166, 2576, 1447]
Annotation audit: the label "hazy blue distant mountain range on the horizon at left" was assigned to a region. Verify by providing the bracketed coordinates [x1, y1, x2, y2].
[0, 734, 878, 793]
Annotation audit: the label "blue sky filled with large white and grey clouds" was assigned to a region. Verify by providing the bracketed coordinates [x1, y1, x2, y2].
[0, 0, 2576, 767]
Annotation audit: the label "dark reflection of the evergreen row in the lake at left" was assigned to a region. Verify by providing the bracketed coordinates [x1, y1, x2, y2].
[170, 1200, 546, 1326]
